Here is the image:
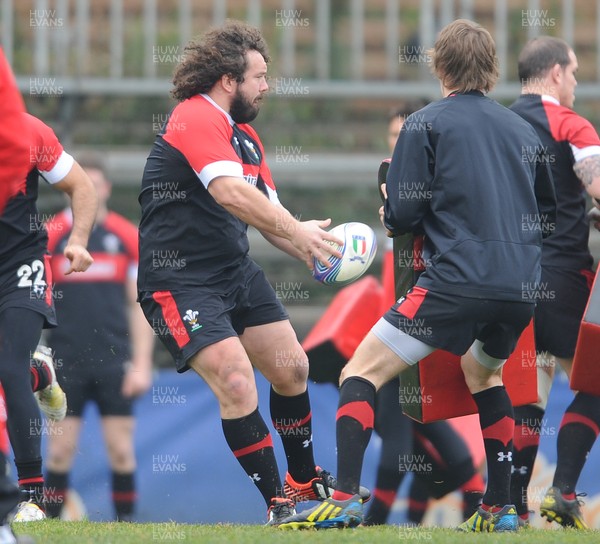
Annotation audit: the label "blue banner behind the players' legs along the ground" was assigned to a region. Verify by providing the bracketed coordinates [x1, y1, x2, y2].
[31, 371, 600, 528]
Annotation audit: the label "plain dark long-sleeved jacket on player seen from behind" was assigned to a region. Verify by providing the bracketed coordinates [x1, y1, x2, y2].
[385, 91, 556, 303]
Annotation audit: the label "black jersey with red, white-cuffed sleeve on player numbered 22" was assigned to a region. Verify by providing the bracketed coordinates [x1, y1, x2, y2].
[0, 114, 73, 271]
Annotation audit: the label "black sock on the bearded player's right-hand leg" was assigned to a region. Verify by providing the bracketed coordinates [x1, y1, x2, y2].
[271, 387, 316, 483]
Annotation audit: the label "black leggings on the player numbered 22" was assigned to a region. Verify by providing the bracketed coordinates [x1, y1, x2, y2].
[0, 308, 44, 476]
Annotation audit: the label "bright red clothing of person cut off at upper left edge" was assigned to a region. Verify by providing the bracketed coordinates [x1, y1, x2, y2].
[0, 49, 31, 213]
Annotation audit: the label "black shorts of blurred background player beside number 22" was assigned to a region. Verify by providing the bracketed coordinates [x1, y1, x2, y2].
[55, 350, 133, 417]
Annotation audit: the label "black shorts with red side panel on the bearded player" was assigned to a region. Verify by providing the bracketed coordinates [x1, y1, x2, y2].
[138, 259, 289, 372]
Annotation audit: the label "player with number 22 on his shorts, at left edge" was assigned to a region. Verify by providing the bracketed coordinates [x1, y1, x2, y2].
[0, 114, 97, 510]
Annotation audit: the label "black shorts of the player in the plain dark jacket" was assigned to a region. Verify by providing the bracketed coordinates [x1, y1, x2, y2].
[383, 286, 535, 359]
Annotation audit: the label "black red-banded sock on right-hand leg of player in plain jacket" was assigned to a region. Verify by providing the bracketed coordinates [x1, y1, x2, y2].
[473, 385, 515, 507]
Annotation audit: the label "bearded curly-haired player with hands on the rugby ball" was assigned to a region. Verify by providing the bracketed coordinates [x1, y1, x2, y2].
[138, 22, 356, 525]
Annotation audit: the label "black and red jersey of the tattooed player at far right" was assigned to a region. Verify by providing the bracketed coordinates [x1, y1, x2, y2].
[510, 94, 600, 270]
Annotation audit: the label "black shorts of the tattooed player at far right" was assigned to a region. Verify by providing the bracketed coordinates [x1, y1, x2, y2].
[534, 266, 594, 359]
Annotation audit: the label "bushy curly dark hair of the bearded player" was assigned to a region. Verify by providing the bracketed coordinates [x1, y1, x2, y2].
[171, 20, 271, 101]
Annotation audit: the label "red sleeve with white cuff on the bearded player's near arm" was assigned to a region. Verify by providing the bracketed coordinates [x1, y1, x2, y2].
[163, 96, 243, 186]
